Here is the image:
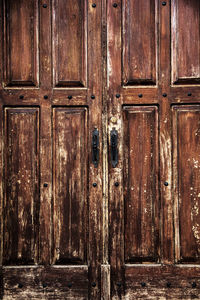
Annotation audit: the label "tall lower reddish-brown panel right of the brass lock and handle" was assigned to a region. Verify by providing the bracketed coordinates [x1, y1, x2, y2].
[123, 106, 159, 262]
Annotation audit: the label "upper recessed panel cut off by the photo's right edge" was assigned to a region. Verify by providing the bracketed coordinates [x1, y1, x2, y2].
[171, 0, 200, 84]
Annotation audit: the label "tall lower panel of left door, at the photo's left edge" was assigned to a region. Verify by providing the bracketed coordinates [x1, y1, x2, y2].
[3, 108, 39, 265]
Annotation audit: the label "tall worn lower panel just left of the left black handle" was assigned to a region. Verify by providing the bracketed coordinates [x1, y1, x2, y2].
[53, 107, 88, 264]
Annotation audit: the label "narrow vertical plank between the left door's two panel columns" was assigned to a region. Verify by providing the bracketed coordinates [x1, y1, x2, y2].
[39, 0, 52, 264]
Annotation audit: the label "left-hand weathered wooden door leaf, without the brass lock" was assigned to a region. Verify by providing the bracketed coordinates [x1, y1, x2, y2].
[0, 0, 102, 300]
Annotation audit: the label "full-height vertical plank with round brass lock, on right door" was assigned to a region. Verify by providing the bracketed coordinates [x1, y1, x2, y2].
[107, 1, 124, 299]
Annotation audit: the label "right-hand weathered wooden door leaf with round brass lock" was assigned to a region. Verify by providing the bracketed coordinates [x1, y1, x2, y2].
[107, 0, 200, 300]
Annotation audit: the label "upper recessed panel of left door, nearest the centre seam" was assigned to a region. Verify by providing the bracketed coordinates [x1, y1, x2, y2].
[53, 0, 87, 87]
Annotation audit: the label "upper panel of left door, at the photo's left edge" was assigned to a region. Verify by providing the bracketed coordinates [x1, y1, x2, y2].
[3, 0, 39, 87]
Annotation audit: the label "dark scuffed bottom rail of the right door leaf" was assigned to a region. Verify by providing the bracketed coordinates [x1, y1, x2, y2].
[124, 265, 200, 300]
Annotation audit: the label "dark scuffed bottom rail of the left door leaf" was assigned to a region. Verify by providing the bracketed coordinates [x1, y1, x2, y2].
[3, 266, 88, 300]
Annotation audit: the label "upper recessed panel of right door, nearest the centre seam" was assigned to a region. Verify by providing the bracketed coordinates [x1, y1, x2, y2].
[123, 0, 157, 85]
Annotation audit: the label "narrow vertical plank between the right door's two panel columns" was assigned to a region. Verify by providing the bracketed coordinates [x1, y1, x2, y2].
[159, 1, 174, 263]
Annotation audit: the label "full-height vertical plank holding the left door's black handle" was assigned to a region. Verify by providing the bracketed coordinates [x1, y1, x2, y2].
[87, 0, 102, 299]
